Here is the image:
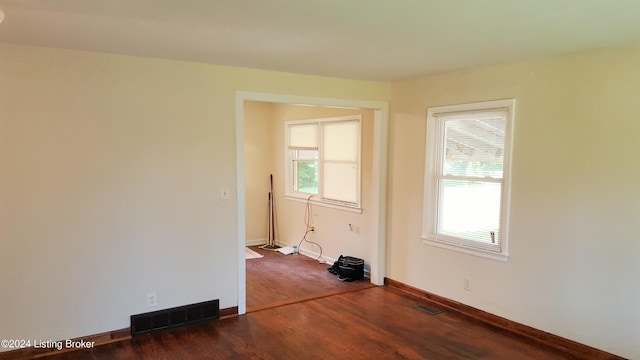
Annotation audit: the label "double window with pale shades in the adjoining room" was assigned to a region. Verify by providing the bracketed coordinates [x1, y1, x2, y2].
[285, 115, 361, 209]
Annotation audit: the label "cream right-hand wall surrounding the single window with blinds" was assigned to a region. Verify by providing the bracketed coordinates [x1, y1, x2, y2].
[387, 46, 640, 358]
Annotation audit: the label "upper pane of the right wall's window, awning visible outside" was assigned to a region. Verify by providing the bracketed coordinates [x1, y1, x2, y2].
[443, 113, 506, 178]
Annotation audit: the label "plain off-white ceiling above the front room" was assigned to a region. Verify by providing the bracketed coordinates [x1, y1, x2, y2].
[0, 0, 640, 81]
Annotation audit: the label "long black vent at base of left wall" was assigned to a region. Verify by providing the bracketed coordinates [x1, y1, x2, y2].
[131, 300, 220, 336]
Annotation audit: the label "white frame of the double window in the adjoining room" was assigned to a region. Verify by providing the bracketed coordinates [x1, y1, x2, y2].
[284, 115, 362, 213]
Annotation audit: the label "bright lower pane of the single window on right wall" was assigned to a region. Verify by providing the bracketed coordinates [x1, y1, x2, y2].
[437, 180, 502, 245]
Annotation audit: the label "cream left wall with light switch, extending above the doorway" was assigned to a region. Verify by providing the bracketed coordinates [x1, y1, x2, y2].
[0, 44, 390, 348]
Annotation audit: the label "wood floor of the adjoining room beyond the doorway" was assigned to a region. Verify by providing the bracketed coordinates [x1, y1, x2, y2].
[246, 246, 375, 312]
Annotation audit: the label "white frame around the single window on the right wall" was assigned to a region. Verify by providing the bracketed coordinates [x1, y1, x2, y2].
[422, 99, 515, 261]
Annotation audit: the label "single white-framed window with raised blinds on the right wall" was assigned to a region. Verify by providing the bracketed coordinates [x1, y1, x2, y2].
[422, 99, 515, 261]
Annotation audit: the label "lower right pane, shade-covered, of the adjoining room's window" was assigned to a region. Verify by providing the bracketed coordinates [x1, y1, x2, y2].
[323, 162, 358, 203]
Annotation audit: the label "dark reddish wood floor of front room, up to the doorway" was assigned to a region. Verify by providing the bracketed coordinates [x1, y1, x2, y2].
[45, 287, 571, 360]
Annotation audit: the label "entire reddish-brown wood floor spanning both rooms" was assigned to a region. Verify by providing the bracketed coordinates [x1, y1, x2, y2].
[6, 249, 616, 360]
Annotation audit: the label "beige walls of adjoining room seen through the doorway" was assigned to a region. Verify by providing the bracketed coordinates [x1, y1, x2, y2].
[244, 102, 376, 265]
